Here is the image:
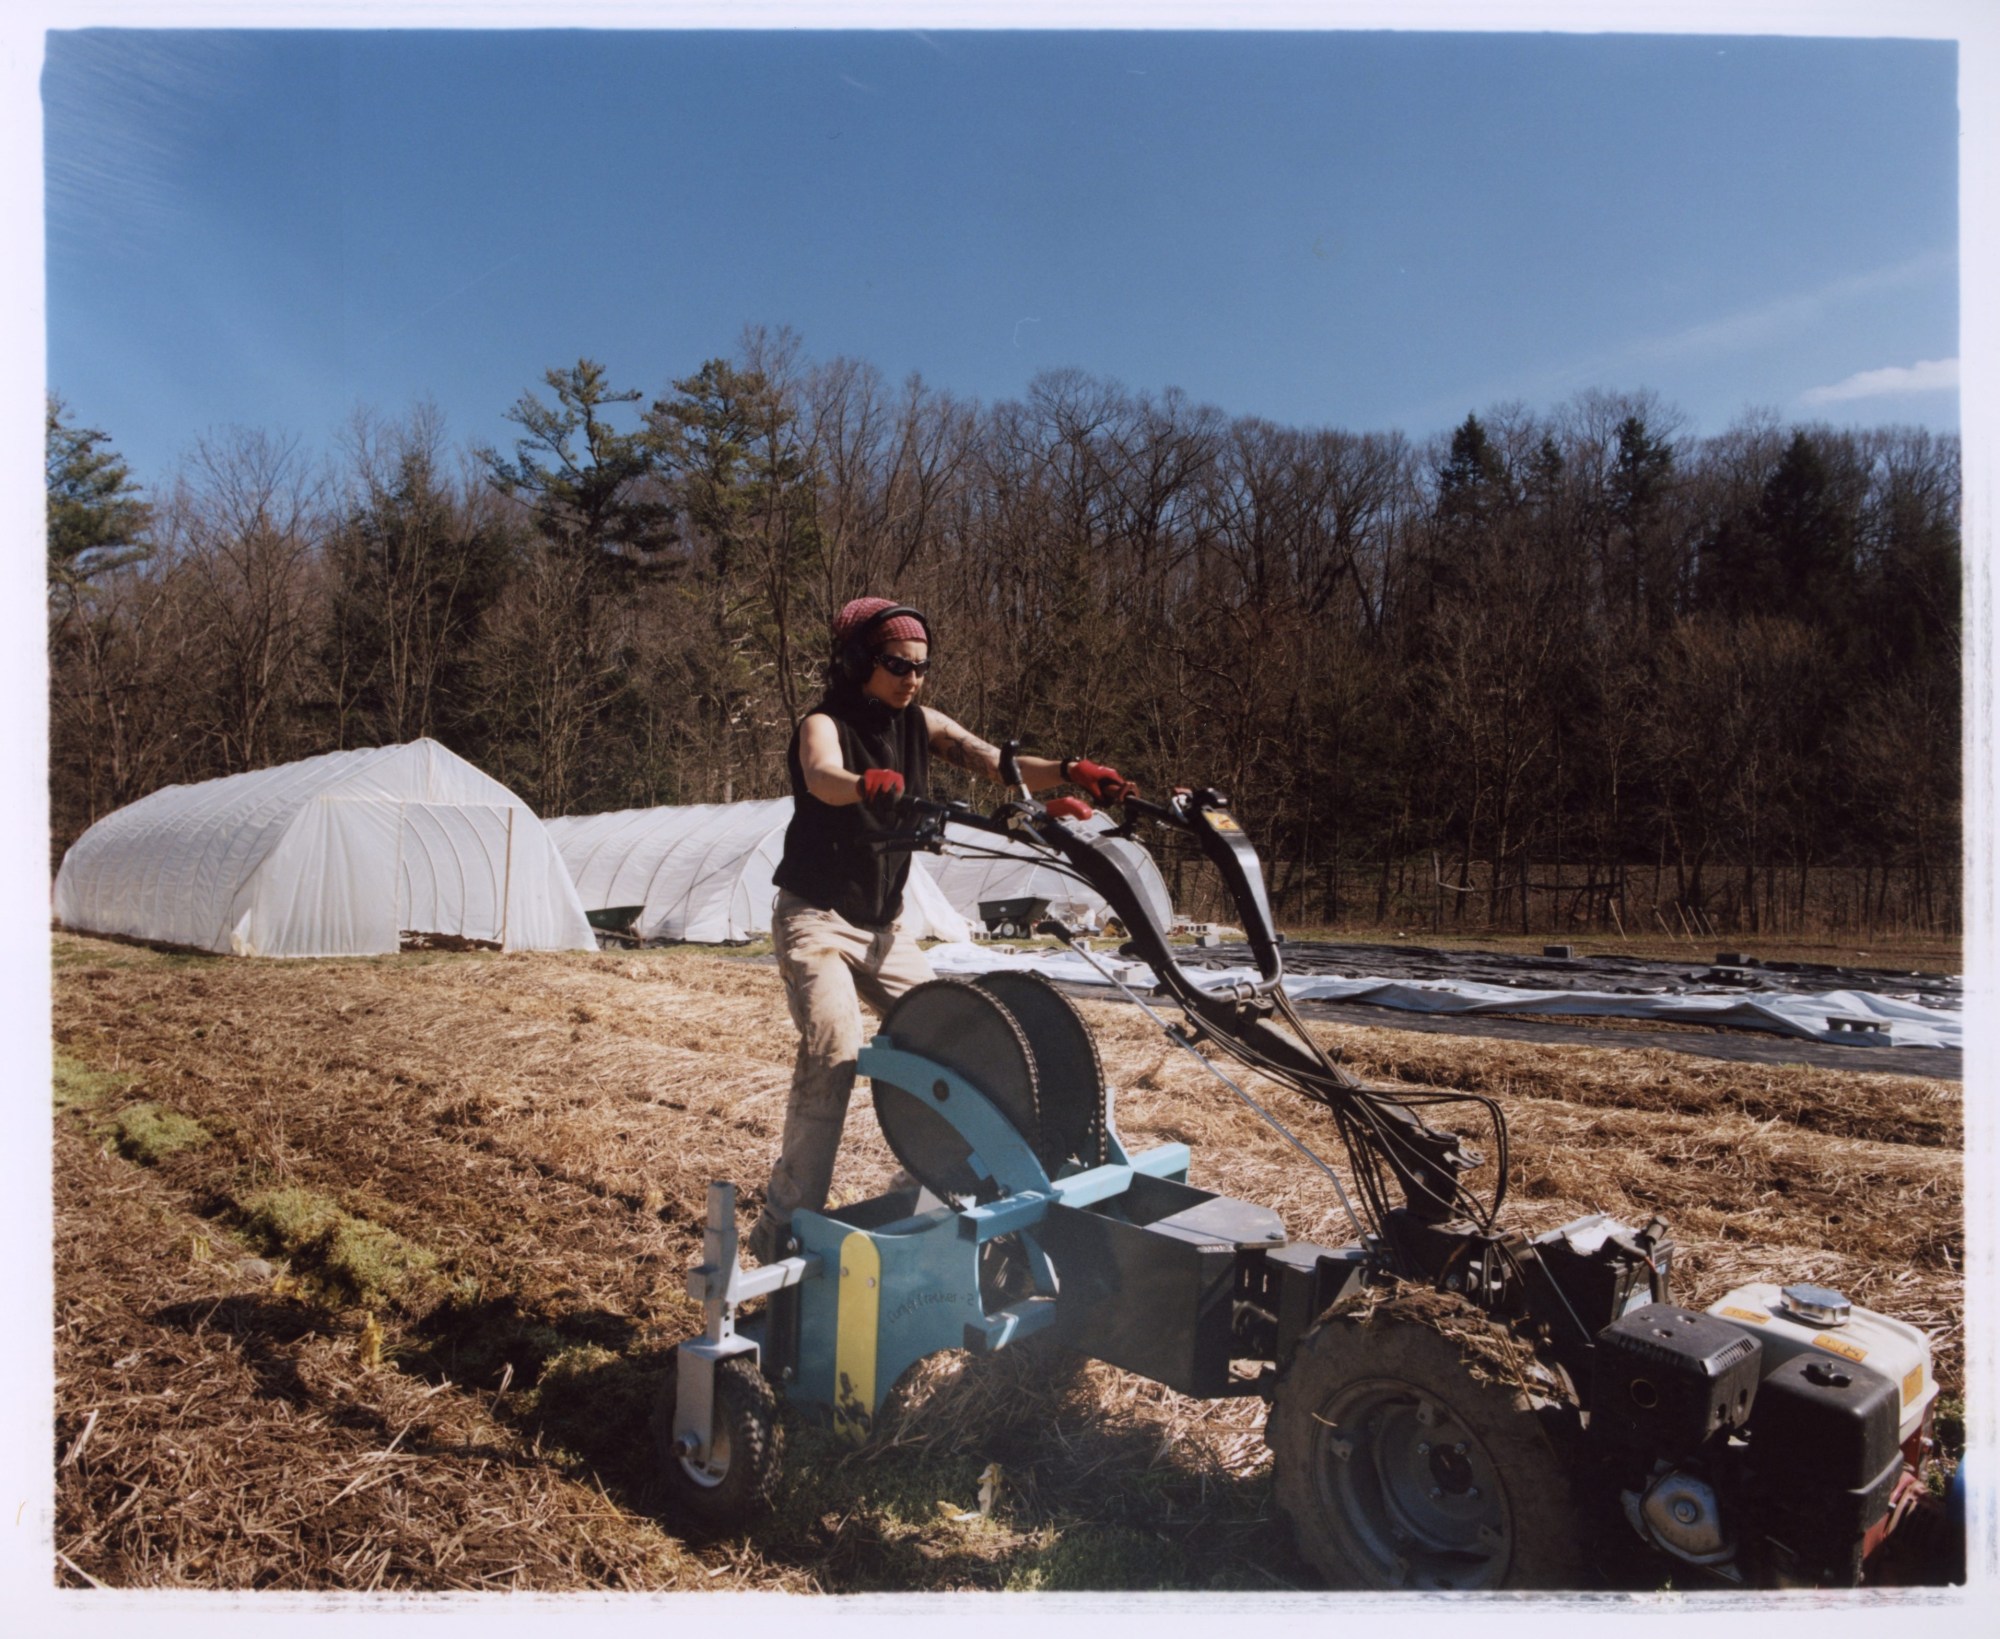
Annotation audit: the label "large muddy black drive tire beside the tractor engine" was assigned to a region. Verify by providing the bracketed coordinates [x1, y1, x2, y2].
[1268, 1305, 1586, 1589]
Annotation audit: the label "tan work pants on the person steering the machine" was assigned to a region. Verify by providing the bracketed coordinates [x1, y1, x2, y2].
[750, 889, 936, 1261]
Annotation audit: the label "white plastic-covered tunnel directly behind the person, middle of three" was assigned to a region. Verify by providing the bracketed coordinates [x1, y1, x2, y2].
[548, 798, 970, 945]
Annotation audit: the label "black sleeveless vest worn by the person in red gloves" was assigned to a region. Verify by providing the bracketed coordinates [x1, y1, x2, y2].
[772, 688, 930, 927]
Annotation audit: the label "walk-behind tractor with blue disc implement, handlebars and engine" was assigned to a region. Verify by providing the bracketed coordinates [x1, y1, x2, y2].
[654, 748, 1938, 1589]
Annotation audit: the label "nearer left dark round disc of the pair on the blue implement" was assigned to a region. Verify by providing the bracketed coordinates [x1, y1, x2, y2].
[874, 979, 1042, 1195]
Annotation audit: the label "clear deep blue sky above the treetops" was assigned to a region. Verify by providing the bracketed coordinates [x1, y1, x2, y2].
[42, 15, 1958, 482]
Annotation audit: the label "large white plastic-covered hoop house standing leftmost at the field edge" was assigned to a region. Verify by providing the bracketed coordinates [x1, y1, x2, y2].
[56, 740, 596, 955]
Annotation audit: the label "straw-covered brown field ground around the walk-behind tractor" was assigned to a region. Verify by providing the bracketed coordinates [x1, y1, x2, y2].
[54, 935, 1962, 1593]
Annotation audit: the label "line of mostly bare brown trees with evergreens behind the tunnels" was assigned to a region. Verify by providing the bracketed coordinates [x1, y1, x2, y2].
[48, 330, 1960, 933]
